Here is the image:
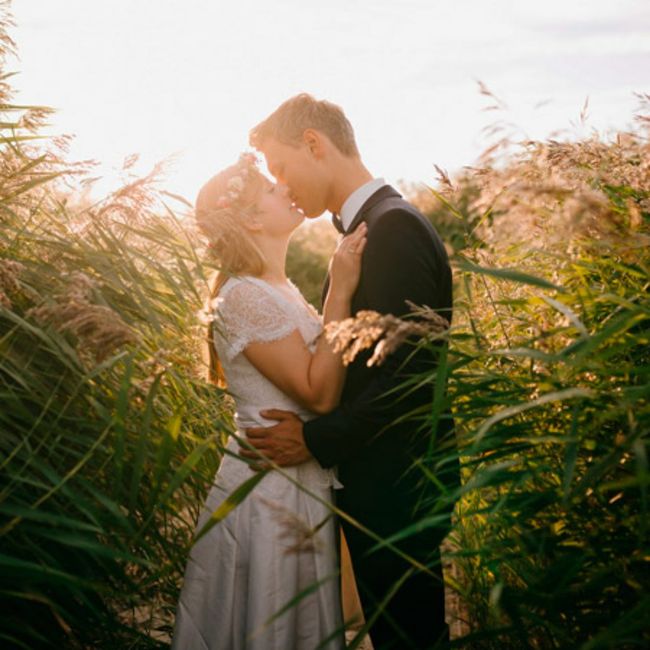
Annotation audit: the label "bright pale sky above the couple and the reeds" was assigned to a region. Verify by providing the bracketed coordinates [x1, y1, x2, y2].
[10, 0, 650, 200]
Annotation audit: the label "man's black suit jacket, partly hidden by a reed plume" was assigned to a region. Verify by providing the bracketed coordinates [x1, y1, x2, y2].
[304, 186, 458, 532]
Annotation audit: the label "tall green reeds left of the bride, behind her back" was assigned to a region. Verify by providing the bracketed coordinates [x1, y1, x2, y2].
[0, 7, 231, 648]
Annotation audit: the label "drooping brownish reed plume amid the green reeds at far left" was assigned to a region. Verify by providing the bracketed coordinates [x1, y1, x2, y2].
[27, 272, 138, 361]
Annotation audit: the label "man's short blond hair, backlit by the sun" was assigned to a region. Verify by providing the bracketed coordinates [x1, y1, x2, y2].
[249, 93, 359, 157]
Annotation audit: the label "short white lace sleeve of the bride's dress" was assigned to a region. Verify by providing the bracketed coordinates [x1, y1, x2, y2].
[215, 281, 296, 360]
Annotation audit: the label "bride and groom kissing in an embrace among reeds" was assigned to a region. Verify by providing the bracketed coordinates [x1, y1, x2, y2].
[173, 94, 458, 650]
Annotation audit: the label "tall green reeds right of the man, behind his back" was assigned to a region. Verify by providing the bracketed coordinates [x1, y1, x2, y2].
[410, 96, 650, 650]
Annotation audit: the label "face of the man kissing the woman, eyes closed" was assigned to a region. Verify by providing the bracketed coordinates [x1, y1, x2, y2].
[260, 138, 328, 217]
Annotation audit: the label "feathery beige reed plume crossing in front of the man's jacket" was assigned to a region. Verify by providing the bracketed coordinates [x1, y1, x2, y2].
[325, 301, 449, 366]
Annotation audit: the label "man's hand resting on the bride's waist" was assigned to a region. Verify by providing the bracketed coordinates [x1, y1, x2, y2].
[239, 409, 312, 470]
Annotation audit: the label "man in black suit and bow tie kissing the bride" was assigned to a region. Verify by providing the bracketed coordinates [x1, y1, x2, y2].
[242, 94, 458, 650]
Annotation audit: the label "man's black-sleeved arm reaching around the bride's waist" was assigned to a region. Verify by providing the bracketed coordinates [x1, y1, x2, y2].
[303, 210, 451, 467]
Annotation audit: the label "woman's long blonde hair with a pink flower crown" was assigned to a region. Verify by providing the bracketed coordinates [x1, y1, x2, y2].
[194, 160, 266, 388]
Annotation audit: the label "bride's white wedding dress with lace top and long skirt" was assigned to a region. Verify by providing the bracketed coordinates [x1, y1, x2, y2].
[172, 276, 345, 650]
